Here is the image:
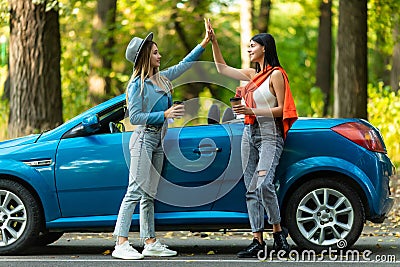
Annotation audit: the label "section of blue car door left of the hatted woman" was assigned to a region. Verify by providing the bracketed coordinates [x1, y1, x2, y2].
[55, 104, 131, 217]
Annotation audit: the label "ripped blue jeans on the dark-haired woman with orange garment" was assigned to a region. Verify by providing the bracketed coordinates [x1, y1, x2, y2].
[242, 119, 283, 233]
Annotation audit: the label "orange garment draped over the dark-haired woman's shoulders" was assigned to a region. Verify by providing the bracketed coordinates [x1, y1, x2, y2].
[236, 66, 298, 139]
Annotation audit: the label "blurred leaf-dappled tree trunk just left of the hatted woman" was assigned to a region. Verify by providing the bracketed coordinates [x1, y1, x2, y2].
[89, 0, 117, 103]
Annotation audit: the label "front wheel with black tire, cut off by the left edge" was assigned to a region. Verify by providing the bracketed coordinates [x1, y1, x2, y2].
[0, 179, 42, 255]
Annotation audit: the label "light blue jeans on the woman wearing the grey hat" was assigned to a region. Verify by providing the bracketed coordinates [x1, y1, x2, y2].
[113, 126, 164, 239]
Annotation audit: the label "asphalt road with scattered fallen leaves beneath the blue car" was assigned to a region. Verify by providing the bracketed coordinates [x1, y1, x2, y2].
[0, 228, 400, 267]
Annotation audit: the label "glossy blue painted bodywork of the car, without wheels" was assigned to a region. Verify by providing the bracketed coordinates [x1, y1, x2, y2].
[0, 95, 393, 230]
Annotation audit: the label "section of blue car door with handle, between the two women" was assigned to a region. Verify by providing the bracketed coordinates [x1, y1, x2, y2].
[155, 124, 231, 212]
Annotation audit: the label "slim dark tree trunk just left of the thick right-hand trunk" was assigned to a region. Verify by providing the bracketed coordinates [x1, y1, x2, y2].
[315, 0, 332, 116]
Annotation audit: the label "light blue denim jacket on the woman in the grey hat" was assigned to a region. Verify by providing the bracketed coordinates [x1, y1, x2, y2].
[127, 45, 205, 125]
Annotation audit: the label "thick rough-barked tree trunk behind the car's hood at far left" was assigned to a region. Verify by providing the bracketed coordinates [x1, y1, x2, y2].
[8, 0, 63, 137]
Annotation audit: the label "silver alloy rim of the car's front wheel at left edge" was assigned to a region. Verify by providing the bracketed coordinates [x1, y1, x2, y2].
[0, 190, 27, 247]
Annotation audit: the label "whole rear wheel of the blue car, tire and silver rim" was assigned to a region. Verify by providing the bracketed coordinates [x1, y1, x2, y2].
[285, 177, 365, 252]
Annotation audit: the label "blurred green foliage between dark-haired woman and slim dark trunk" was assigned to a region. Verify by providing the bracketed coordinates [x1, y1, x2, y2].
[269, 0, 321, 116]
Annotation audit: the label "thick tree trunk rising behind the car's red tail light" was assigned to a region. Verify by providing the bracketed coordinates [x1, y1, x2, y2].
[334, 0, 368, 119]
